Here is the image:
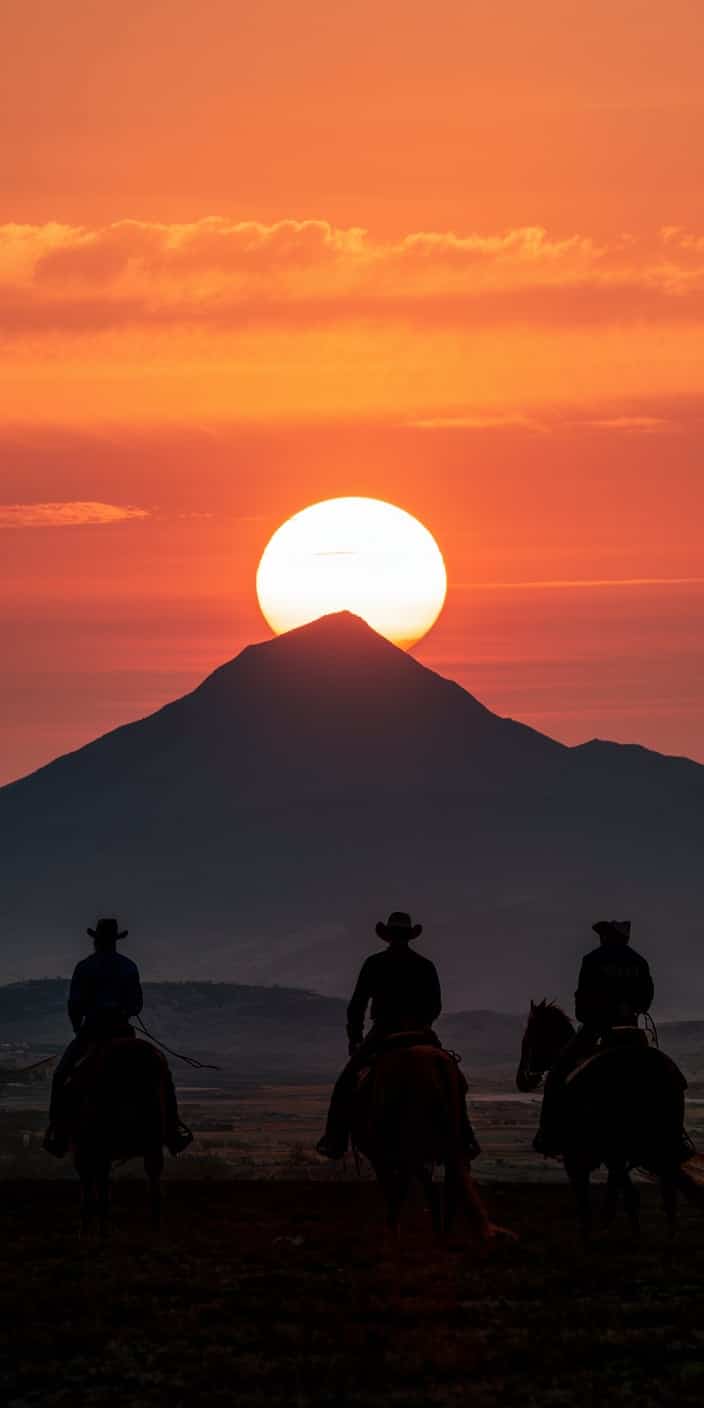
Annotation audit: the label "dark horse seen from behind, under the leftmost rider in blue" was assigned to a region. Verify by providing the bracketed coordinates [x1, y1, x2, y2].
[66, 1038, 168, 1235]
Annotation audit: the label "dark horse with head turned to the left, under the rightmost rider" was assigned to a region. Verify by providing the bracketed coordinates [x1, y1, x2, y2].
[515, 1000, 692, 1240]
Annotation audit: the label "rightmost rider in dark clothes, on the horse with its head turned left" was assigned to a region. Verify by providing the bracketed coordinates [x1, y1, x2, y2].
[534, 919, 655, 1155]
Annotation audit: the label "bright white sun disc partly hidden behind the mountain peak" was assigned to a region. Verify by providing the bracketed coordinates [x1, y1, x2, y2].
[256, 498, 448, 649]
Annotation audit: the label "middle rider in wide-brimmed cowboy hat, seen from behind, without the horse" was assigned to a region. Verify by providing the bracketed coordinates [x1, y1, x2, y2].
[315, 911, 479, 1159]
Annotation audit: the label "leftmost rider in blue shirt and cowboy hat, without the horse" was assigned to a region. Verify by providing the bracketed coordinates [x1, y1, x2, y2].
[44, 918, 193, 1159]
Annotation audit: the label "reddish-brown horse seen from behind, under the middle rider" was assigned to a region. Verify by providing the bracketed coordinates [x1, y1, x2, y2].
[351, 1036, 500, 1243]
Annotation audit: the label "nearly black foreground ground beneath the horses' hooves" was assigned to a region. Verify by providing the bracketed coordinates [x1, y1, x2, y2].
[0, 1181, 704, 1408]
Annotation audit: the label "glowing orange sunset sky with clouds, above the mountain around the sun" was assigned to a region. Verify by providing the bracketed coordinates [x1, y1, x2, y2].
[0, 0, 704, 783]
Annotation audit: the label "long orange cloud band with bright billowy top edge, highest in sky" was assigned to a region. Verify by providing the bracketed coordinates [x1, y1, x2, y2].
[0, 215, 704, 337]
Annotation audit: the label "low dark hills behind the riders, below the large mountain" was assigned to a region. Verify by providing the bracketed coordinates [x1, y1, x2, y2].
[0, 979, 704, 1083]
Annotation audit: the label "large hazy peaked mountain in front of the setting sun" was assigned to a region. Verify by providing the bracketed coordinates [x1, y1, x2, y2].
[0, 612, 704, 1017]
